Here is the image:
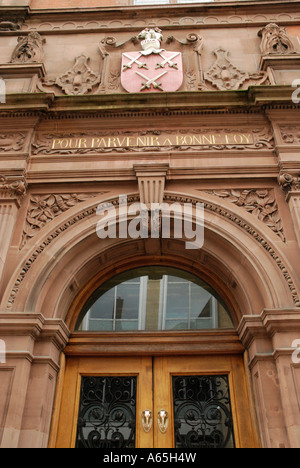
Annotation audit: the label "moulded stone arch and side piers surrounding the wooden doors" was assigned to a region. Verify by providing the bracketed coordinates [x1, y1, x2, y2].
[3, 194, 297, 446]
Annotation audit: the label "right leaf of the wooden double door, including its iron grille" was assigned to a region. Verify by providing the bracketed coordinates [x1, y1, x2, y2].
[154, 356, 256, 448]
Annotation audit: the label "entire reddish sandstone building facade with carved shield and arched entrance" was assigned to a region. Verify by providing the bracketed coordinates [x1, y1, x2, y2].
[0, 0, 300, 448]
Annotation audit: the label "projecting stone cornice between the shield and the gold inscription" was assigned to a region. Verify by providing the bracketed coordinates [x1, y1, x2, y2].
[0, 86, 300, 116]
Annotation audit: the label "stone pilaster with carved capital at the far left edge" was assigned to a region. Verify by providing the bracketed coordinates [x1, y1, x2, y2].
[0, 175, 26, 281]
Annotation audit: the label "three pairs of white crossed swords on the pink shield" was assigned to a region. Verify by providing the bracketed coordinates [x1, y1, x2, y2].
[123, 52, 180, 91]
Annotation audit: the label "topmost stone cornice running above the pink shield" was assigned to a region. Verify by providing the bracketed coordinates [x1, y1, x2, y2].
[0, 0, 300, 35]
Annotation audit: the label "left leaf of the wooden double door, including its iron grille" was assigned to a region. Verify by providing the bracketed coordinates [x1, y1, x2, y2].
[56, 358, 153, 448]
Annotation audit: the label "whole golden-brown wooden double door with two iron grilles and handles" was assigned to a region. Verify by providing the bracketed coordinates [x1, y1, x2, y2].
[55, 355, 257, 449]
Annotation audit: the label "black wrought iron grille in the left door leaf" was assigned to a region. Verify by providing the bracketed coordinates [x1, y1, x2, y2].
[76, 377, 137, 448]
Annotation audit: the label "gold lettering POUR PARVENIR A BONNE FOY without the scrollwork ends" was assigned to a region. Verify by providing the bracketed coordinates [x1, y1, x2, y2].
[52, 133, 254, 150]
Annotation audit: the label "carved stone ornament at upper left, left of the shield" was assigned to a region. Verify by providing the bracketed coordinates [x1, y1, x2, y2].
[11, 32, 46, 63]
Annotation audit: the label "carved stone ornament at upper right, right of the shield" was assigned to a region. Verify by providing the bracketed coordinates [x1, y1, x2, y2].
[258, 23, 297, 55]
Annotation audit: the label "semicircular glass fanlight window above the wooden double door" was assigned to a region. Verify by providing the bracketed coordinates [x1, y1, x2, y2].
[76, 266, 234, 332]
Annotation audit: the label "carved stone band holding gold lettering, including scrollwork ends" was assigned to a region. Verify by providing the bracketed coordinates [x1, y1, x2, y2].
[32, 128, 273, 155]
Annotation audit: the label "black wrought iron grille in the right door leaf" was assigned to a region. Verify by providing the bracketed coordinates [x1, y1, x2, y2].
[173, 375, 235, 449]
